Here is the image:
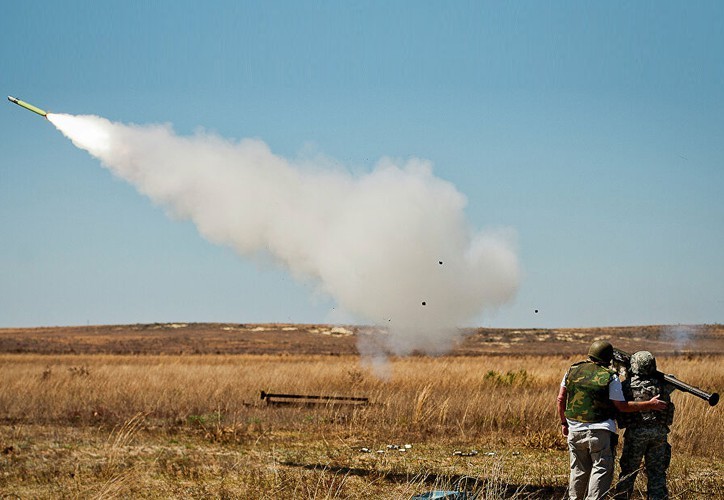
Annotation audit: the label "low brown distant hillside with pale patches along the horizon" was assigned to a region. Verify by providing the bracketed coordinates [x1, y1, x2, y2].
[0, 323, 724, 356]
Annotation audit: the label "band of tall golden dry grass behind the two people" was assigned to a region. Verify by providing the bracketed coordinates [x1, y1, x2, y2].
[0, 355, 724, 456]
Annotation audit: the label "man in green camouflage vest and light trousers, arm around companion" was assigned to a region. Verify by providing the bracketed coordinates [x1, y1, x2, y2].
[557, 340, 666, 500]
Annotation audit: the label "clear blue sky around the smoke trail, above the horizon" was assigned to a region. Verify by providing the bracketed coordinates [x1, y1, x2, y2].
[0, 1, 724, 327]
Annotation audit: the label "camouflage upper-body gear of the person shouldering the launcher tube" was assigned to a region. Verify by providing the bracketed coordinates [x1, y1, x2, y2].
[616, 375, 674, 427]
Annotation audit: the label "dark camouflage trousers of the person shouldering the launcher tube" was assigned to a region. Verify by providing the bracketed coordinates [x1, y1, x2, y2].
[615, 425, 671, 500]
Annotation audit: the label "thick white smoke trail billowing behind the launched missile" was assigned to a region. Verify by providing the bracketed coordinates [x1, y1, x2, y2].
[48, 114, 519, 354]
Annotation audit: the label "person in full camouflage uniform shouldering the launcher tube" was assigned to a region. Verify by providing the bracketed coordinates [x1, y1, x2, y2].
[615, 351, 675, 500]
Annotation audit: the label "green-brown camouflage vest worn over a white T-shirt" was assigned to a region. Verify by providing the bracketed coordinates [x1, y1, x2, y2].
[565, 361, 614, 423]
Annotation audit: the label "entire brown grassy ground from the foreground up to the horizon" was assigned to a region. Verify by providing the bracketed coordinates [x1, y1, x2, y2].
[0, 324, 724, 499]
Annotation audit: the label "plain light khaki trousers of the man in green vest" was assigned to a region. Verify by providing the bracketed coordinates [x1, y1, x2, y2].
[568, 429, 618, 500]
